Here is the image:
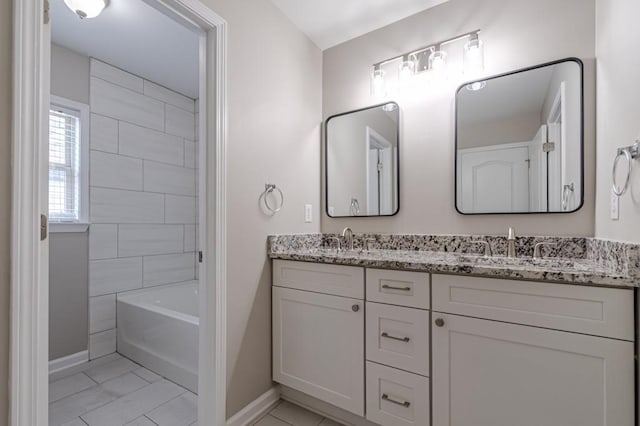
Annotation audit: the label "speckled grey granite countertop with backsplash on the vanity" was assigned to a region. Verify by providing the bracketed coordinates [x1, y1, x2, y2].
[268, 234, 640, 288]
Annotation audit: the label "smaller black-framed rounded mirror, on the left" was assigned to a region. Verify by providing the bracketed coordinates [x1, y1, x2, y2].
[325, 102, 400, 217]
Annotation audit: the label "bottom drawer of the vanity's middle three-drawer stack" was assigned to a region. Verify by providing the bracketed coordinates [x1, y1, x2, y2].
[366, 362, 429, 426]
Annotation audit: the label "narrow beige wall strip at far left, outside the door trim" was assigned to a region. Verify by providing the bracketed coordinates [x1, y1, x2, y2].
[0, 0, 13, 425]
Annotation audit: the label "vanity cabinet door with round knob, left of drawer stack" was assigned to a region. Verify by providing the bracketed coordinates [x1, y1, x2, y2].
[273, 287, 364, 416]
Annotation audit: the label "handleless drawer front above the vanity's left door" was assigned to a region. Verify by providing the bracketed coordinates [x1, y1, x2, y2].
[273, 259, 364, 299]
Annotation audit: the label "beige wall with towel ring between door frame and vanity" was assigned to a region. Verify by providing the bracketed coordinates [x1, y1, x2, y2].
[204, 0, 322, 415]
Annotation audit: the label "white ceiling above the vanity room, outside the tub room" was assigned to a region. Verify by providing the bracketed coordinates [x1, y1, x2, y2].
[272, 0, 448, 50]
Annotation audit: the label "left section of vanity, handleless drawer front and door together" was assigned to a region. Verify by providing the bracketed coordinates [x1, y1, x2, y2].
[272, 260, 365, 416]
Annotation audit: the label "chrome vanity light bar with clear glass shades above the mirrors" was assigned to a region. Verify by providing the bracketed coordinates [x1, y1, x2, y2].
[371, 30, 484, 97]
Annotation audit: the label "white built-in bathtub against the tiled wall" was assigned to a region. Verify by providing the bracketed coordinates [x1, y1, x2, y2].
[117, 281, 200, 393]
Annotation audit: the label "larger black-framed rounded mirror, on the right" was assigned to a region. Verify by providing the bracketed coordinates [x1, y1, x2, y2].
[455, 58, 583, 214]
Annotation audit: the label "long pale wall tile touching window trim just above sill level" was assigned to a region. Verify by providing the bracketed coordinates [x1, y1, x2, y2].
[89, 188, 164, 223]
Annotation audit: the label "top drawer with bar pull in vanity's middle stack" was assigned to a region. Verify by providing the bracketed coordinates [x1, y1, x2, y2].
[367, 268, 429, 309]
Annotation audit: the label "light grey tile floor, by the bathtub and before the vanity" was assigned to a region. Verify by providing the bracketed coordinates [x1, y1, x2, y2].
[49, 354, 340, 426]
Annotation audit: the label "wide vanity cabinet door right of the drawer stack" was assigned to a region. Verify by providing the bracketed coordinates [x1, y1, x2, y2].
[432, 313, 634, 426]
